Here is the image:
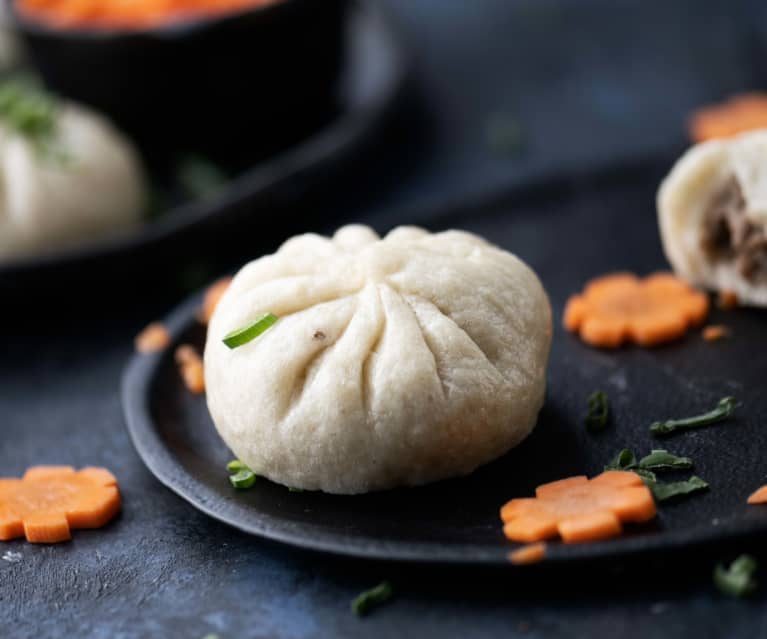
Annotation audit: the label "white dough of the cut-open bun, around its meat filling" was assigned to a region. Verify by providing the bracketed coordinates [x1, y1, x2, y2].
[657, 130, 767, 306]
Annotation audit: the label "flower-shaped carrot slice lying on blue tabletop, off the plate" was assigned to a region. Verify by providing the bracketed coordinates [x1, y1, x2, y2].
[0, 466, 120, 543]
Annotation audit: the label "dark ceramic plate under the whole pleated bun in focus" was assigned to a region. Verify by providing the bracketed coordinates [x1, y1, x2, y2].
[123, 162, 767, 563]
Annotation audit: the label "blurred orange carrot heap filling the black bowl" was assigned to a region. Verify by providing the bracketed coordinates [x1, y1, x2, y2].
[16, 0, 279, 29]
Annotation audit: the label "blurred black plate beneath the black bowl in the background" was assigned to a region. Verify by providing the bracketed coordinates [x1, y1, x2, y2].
[0, 1, 408, 292]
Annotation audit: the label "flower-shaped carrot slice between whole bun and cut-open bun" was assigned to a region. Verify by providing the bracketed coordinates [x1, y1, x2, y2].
[563, 273, 708, 348]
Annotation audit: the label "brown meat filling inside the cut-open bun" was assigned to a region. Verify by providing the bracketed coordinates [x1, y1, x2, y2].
[701, 177, 767, 281]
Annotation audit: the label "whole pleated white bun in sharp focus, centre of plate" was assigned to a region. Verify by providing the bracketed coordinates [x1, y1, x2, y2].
[205, 226, 551, 493]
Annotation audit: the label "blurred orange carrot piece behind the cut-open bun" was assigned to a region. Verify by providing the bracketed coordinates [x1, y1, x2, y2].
[688, 92, 767, 142]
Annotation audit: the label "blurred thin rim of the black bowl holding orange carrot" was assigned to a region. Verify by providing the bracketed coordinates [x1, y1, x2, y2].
[5, 0, 334, 42]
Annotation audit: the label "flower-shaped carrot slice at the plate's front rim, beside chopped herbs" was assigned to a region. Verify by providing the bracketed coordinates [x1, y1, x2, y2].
[501, 470, 655, 543]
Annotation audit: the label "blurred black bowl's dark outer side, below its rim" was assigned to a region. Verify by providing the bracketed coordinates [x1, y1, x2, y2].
[14, 0, 348, 170]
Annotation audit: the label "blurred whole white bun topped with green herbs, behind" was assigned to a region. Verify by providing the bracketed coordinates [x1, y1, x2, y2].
[0, 104, 145, 259]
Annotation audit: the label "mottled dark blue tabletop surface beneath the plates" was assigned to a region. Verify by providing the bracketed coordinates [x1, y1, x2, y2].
[0, 0, 767, 639]
